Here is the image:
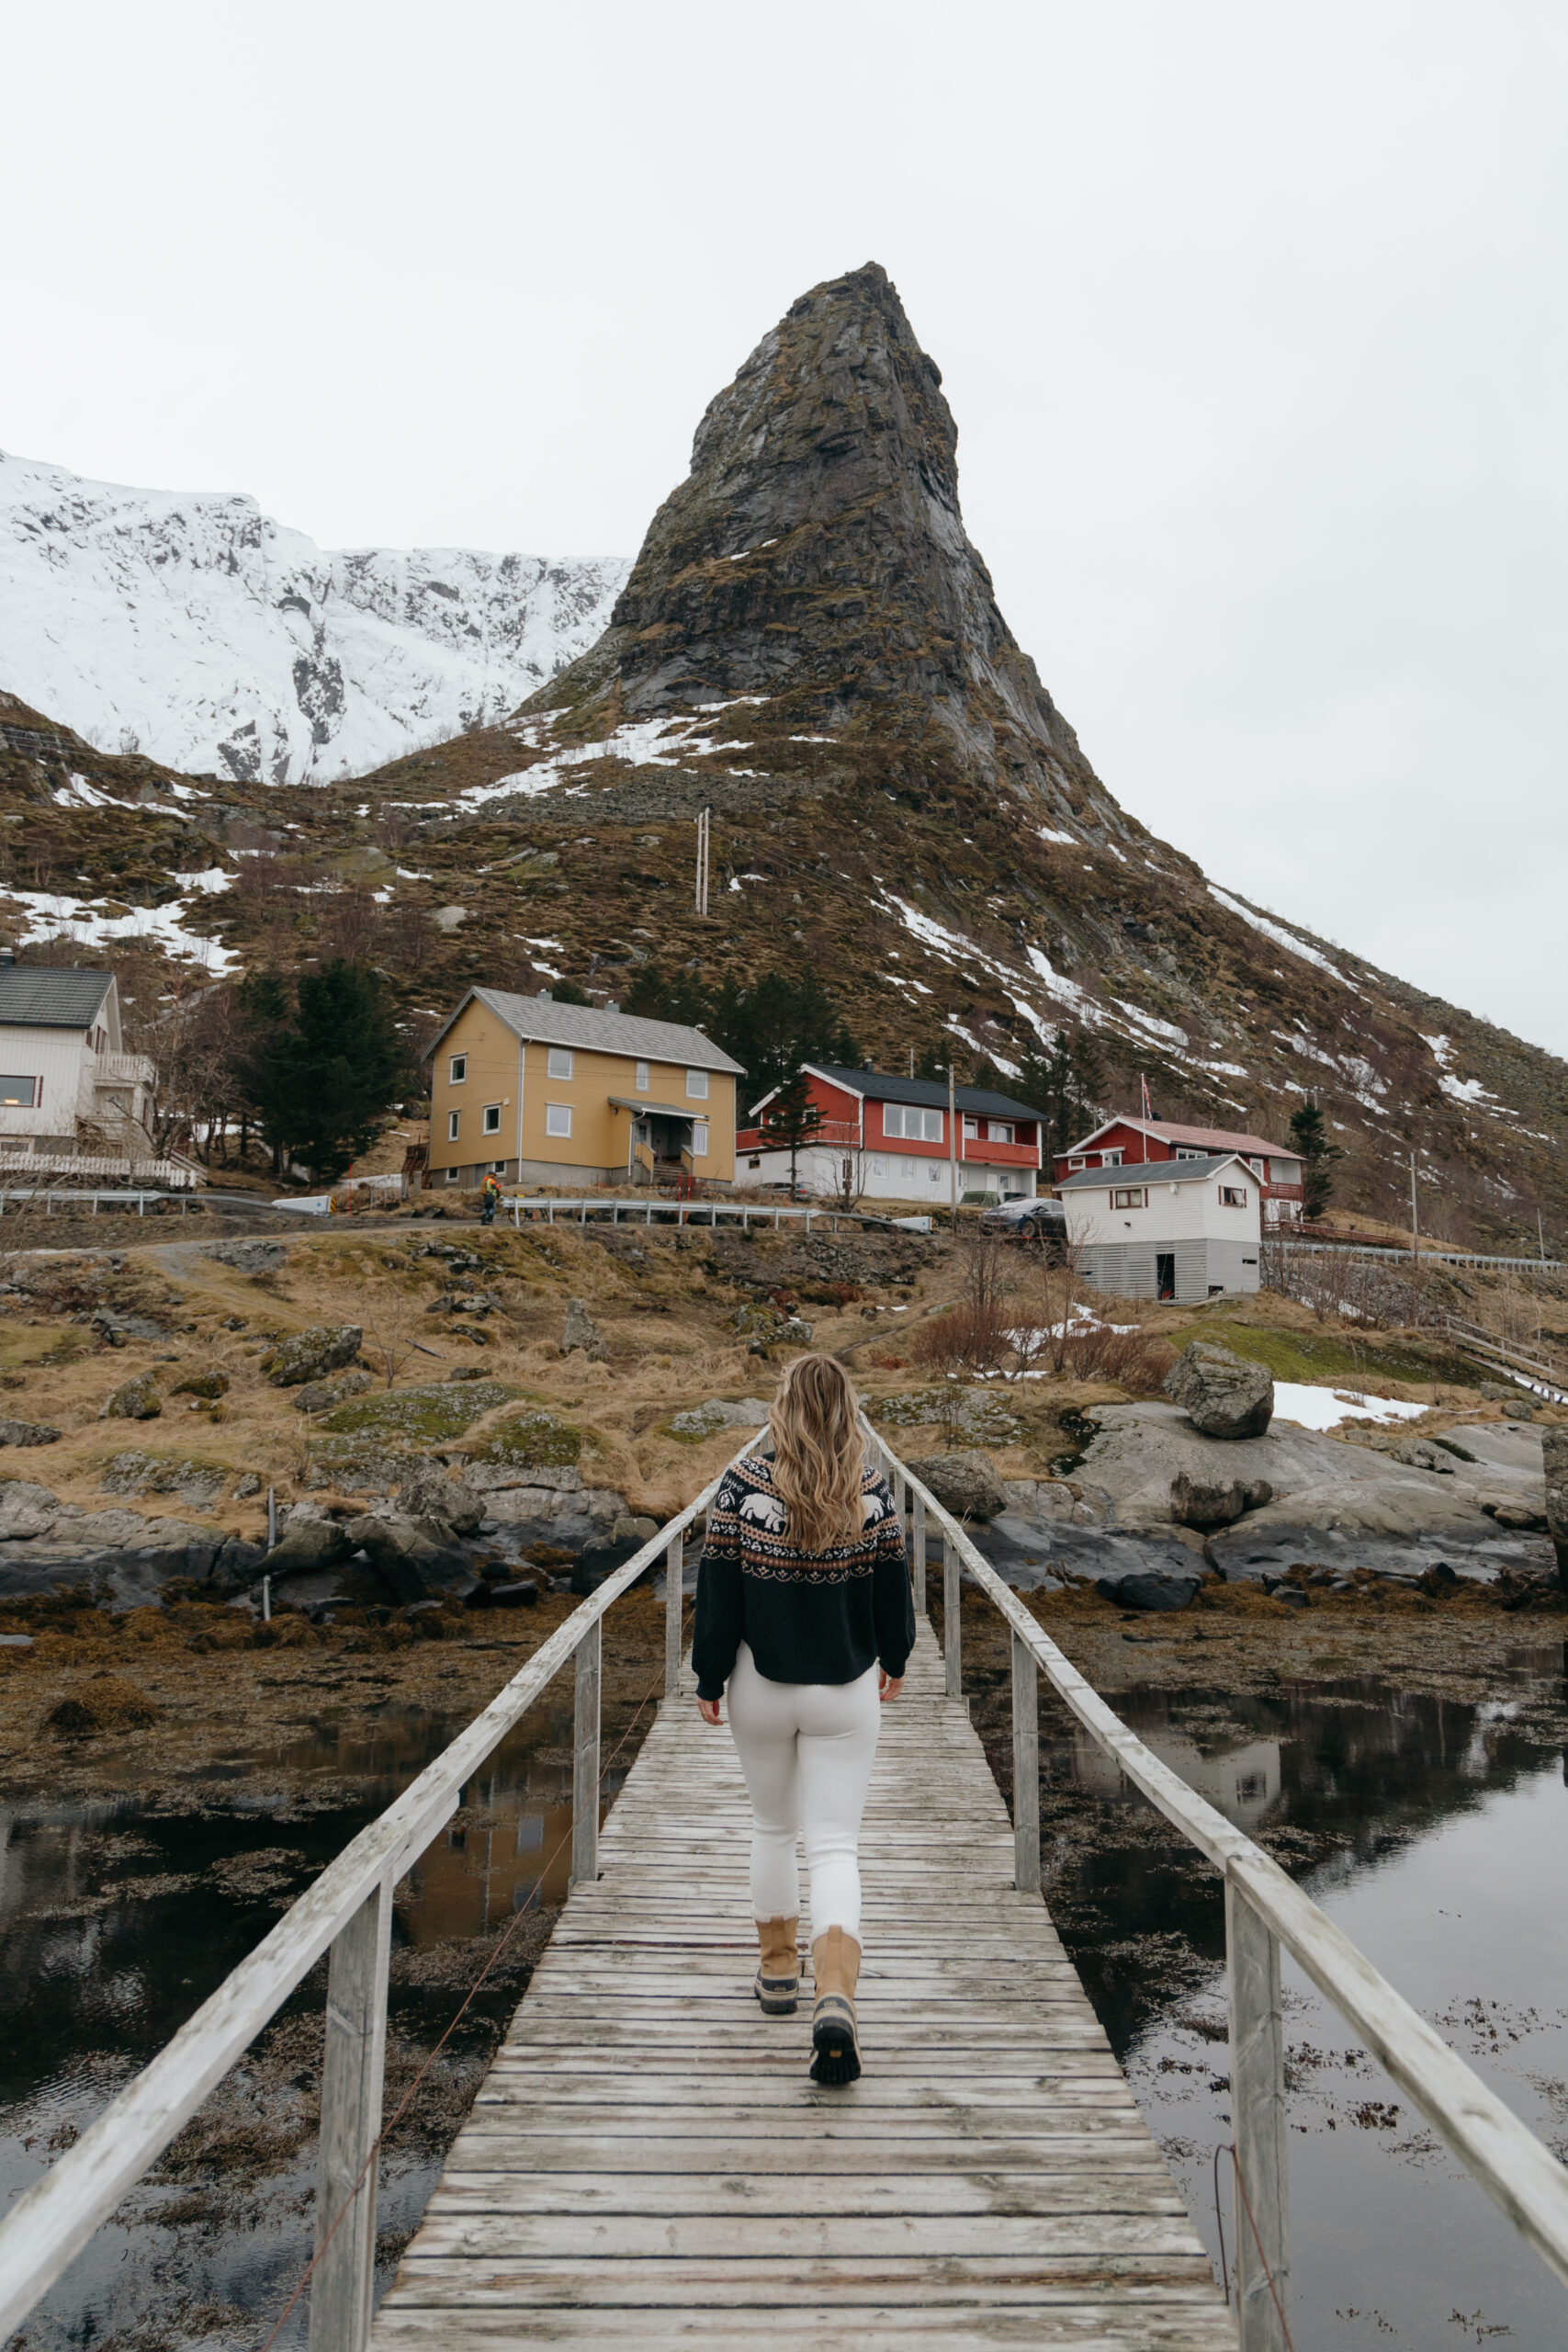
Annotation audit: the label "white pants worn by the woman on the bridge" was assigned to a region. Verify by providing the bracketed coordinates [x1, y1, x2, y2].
[728, 1642, 882, 1943]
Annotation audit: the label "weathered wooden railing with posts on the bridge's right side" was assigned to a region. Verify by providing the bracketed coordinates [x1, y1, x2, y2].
[867, 1423, 1568, 2352]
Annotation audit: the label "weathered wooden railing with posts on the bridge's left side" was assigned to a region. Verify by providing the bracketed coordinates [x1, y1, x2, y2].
[0, 1432, 755, 2352]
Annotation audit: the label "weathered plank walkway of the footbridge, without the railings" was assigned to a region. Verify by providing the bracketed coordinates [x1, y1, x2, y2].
[371, 1623, 1236, 2352]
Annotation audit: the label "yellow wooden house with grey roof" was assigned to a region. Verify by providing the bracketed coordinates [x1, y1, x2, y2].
[428, 988, 745, 1185]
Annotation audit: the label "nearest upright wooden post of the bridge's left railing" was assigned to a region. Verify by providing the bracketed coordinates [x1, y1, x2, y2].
[310, 1879, 392, 2352]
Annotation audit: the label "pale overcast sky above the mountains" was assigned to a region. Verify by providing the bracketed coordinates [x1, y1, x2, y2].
[0, 0, 1568, 1054]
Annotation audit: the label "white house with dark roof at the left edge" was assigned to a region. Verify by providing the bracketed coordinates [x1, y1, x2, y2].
[0, 950, 163, 1176]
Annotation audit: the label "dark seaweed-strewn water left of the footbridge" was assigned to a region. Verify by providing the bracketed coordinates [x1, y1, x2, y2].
[0, 1708, 623, 2352]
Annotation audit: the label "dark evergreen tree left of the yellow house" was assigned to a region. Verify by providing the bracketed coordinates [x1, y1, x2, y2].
[247, 959, 409, 1183]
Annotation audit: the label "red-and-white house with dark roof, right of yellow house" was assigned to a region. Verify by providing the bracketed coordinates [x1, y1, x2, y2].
[736, 1063, 1042, 1206]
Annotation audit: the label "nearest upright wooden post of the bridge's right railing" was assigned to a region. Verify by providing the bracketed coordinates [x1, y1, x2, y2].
[1224, 1879, 1291, 2352]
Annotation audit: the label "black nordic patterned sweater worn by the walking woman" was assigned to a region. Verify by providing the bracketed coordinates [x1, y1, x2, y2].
[691, 1453, 915, 1698]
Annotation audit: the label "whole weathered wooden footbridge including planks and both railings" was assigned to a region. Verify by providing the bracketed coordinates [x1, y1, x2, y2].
[0, 1432, 1568, 2352]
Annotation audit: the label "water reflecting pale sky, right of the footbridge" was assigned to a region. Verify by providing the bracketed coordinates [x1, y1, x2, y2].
[1046, 1644, 1568, 2352]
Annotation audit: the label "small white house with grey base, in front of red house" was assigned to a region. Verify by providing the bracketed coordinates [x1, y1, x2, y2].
[1055, 1152, 1262, 1303]
